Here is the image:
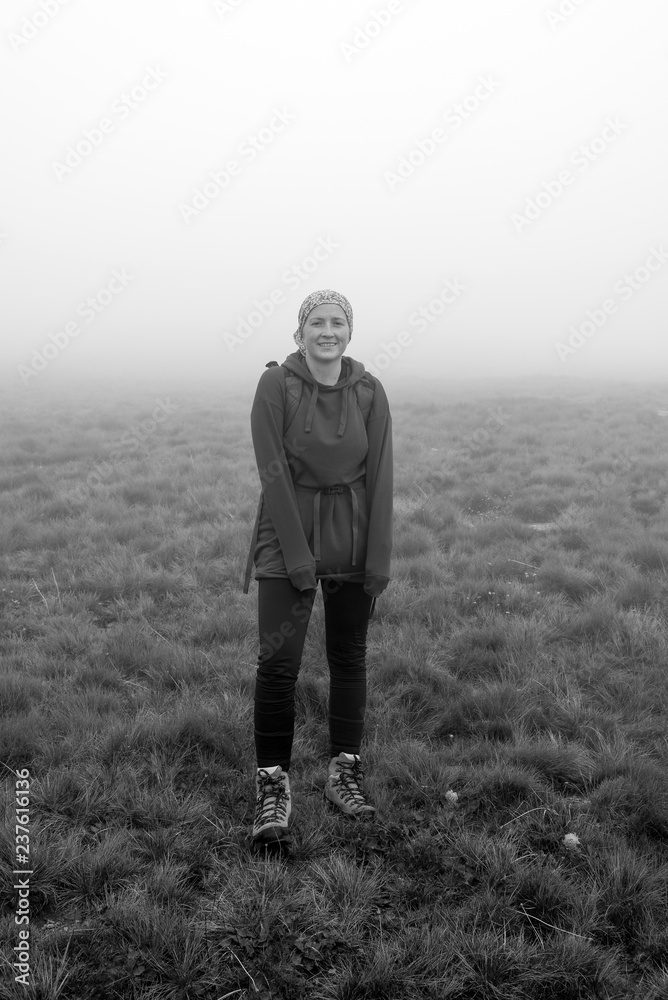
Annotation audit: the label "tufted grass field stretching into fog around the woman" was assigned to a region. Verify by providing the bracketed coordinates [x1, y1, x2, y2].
[0, 379, 668, 1000]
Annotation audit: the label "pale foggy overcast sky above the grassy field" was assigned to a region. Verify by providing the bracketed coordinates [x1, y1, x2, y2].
[0, 0, 668, 388]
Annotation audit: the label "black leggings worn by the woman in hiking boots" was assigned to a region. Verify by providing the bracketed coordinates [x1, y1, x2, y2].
[254, 579, 372, 771]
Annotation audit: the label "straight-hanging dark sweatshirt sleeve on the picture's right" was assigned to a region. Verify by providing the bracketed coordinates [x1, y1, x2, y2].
[364, 381, 393, 597]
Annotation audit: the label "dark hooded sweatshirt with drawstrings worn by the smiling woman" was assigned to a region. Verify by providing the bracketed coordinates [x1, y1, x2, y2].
[244, 351, 392, 597]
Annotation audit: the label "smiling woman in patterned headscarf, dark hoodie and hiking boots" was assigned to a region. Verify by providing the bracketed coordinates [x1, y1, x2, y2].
[244, 289, 392, 844]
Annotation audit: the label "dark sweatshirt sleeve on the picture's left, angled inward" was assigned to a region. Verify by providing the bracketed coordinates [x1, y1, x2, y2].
[251, 367, 317, 590]
